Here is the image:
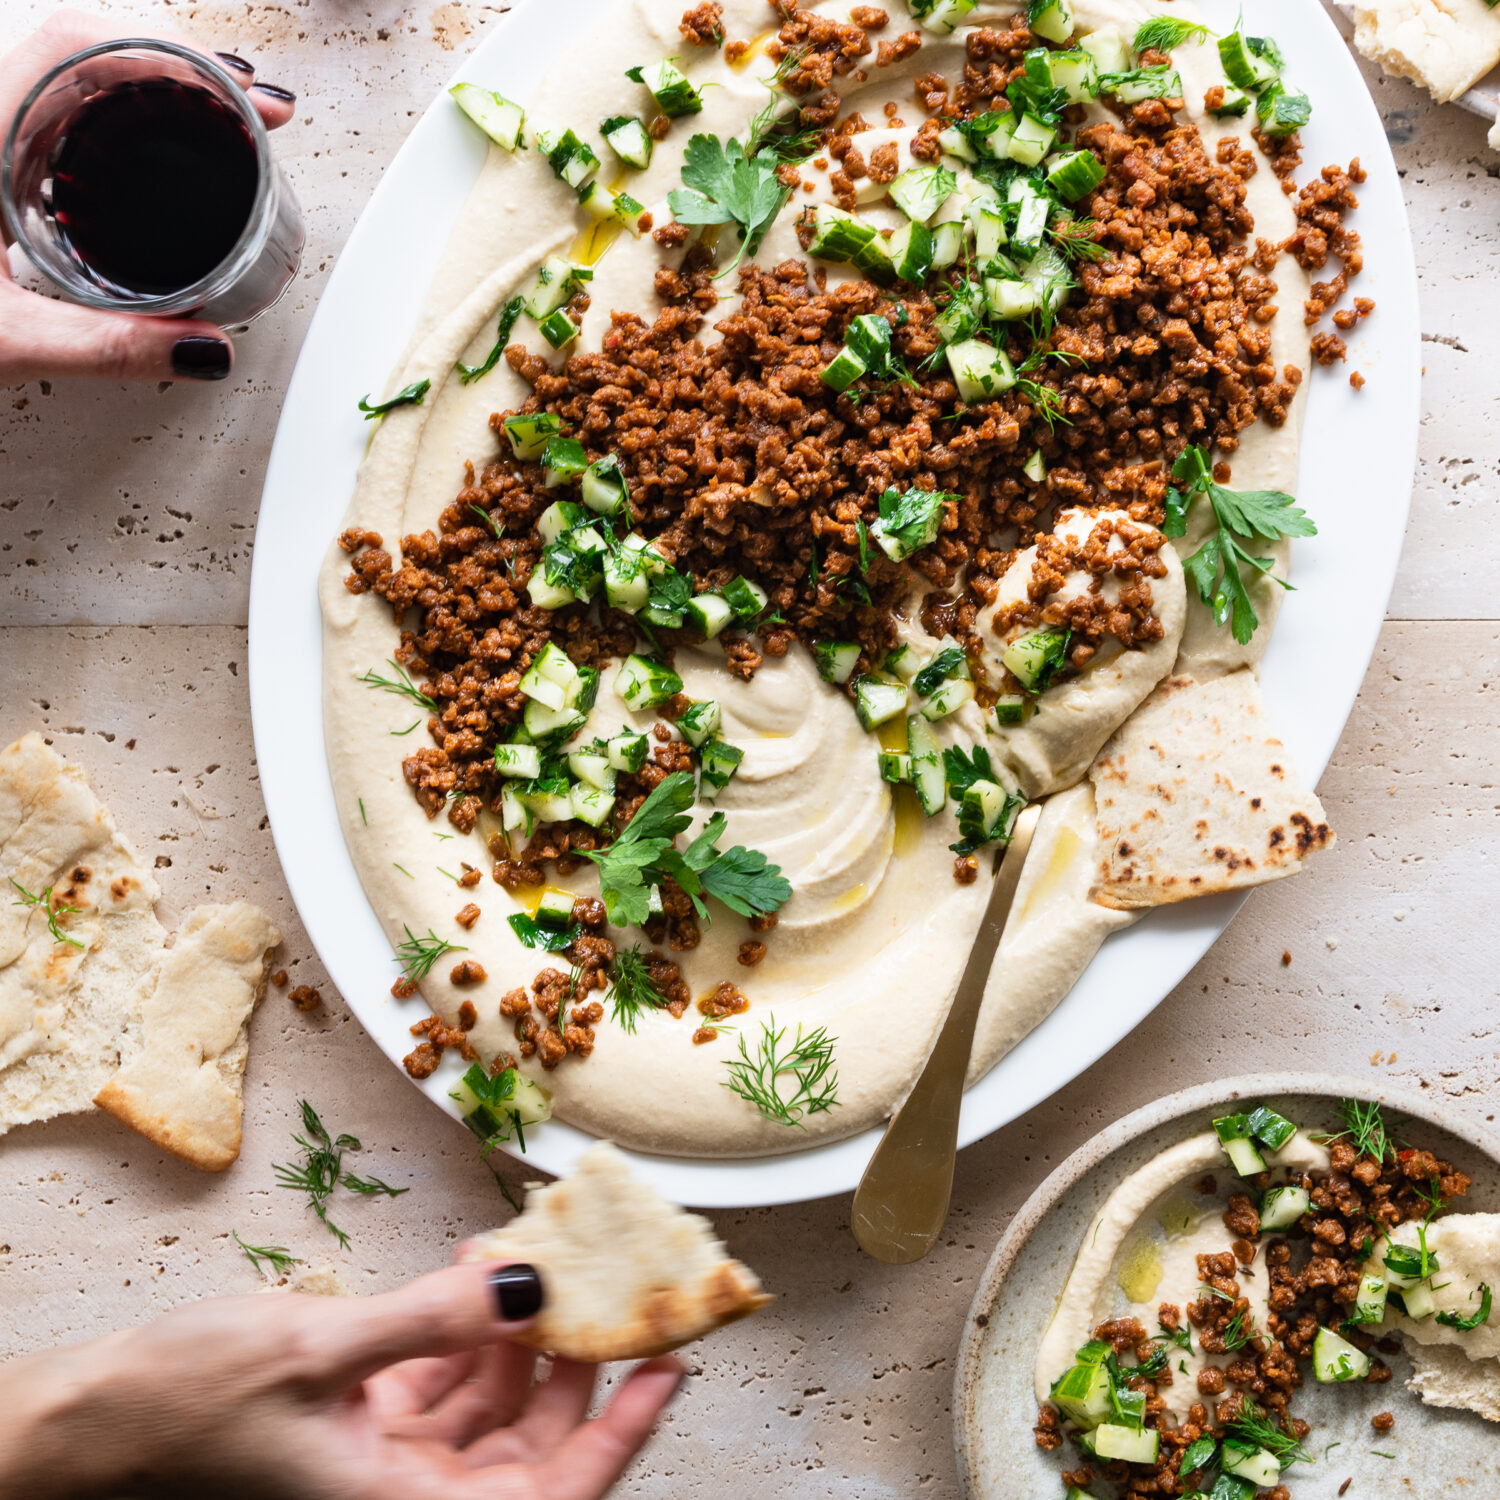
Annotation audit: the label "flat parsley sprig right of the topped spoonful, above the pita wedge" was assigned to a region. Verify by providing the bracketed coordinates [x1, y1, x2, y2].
[1161, 447, 1317, 645]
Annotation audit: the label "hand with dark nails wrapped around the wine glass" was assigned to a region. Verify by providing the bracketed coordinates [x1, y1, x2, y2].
[0, 11, 296, 386]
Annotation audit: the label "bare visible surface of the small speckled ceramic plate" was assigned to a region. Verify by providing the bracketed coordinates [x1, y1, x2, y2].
[953, 1073, 1500, 1500]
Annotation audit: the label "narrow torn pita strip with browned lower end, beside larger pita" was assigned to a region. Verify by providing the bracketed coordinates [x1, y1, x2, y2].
[95, 902, 281, 1172]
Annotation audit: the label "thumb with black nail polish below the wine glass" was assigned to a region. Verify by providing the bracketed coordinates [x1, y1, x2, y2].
[0, 281, 234, 386]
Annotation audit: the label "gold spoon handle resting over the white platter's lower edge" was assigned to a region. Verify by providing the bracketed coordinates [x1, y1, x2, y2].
[852, 803, 1041, 1266]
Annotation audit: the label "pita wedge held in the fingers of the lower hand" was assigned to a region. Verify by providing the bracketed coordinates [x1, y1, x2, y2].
[467, 1143, 771, 1364]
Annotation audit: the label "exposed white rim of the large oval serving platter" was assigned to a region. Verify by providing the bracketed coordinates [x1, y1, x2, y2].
[249, 0, 1422, 1208]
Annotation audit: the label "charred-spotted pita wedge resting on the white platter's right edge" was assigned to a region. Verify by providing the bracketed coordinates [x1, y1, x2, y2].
[1089, 671, 1334, 911]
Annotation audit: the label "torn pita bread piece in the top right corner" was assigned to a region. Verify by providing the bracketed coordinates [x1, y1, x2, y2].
[1355, 0, 1500, 104]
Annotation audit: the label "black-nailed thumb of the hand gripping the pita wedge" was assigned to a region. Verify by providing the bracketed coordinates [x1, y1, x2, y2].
[298, 1262, 543, 1388]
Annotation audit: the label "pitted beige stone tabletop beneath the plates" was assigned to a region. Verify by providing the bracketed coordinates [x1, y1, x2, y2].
[0, 0, 1500, 1500]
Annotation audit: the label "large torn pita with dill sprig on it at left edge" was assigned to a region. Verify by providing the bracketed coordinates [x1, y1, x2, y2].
[0, 734, 167, 1136]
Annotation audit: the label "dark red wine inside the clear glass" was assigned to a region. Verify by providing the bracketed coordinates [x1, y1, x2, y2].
[51, 78, 258, 296]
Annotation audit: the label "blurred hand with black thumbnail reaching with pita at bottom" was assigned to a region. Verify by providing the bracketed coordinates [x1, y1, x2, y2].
[0, 1263, 683, 1500]
